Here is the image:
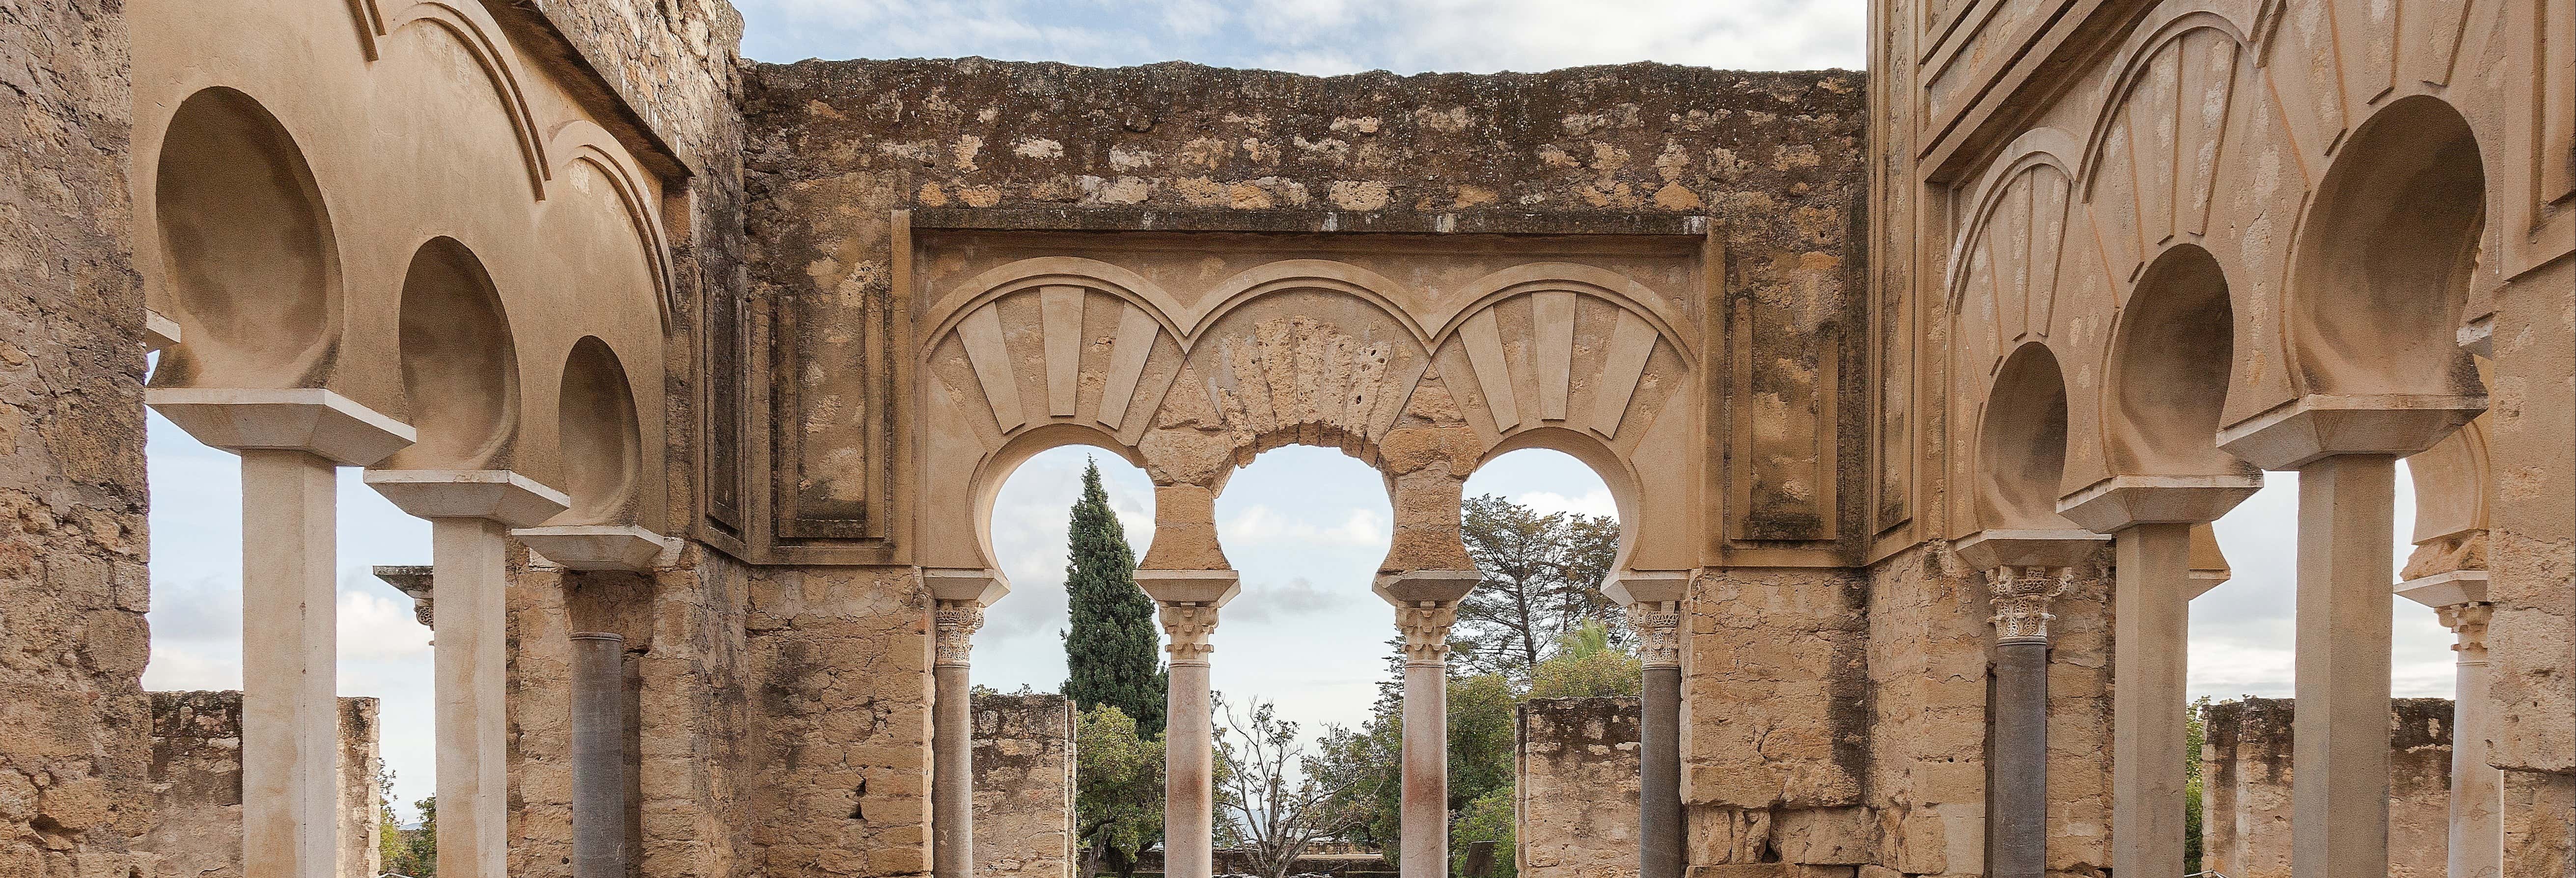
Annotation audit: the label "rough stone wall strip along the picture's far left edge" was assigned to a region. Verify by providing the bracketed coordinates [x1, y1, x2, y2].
[0, 0, 152, 876]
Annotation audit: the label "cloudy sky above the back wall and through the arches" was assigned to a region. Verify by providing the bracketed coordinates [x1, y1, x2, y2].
[144, 0, 2450, 814]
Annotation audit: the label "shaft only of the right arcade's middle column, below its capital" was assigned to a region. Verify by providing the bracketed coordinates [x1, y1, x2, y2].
[2110, 522, 2192, 876]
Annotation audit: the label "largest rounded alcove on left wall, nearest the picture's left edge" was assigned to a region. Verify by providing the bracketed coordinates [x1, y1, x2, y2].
[152, 87, 340, 386]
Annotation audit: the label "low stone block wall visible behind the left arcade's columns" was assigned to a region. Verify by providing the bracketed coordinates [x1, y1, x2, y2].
[134, 690, 384, 878]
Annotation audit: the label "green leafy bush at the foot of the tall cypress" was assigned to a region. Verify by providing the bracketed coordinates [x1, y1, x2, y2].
[1074, 706, 1162, 878]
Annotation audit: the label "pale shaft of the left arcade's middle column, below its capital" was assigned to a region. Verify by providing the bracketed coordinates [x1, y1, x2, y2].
[430, 518, 510, 878]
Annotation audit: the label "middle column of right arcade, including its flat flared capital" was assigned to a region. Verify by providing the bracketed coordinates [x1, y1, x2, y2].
[2058, 476, 2262, 876]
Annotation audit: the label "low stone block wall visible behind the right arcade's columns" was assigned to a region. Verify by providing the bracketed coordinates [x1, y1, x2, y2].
[2200, 698, 2452, 878]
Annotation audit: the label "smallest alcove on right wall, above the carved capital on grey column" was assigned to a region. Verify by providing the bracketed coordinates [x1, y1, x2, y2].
[1976, 342, 2071, 530]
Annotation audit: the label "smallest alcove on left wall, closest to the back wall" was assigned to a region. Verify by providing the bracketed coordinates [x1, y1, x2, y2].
[556, 335, 644, 525]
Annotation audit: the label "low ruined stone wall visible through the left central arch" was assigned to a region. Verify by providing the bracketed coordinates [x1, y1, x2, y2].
[974, 692, 1080, 878]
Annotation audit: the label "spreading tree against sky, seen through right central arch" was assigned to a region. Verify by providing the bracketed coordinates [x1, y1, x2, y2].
[1450, 494, 1620, 680]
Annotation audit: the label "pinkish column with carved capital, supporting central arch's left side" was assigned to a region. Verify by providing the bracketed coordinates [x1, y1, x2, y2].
[1162, 603, 1216, 878]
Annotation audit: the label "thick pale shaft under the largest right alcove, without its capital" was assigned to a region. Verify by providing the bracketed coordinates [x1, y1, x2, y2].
[2290, 453, 2396, 878]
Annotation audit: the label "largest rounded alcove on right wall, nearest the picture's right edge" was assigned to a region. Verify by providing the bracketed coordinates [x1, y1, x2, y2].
[2290, 95, 2486, 394]
